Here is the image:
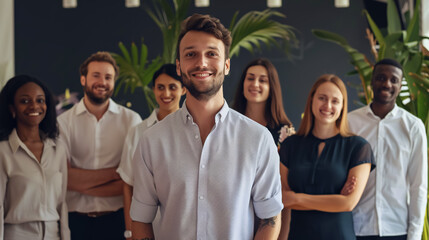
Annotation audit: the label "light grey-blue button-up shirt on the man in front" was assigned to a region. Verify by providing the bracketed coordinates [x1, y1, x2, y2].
[131, 103, 283, 239]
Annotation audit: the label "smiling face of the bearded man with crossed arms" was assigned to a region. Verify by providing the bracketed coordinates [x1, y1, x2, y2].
[80, 61, 115, 105]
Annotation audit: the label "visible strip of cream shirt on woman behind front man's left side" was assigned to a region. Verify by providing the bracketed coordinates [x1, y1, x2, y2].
[116, 109, 159, 186]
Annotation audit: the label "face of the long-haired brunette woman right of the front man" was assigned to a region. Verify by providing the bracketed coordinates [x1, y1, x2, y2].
[243, 65, 270, 103]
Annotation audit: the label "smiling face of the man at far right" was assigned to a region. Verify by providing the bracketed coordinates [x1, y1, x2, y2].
[371, 65, 402, 106]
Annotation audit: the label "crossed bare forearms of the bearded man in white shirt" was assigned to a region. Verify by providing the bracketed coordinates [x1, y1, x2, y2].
[67, 165, 123, 197]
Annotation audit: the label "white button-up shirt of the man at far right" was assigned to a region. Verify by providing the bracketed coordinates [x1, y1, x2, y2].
[348, 105, 428, 240]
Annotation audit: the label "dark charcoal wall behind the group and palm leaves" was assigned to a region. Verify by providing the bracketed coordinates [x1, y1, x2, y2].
[15, 0, 369, 126]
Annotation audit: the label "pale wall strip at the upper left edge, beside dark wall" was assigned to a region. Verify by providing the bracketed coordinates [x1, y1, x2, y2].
[0, 0, 15, 88]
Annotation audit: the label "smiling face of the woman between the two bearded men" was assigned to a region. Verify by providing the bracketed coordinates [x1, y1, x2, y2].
[153, 73, 186, 113]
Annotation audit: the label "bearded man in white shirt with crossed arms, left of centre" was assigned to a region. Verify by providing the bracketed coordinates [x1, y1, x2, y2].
[58, 52, 141, 240]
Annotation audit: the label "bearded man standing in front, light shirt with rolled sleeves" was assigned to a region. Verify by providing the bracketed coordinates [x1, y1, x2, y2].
[130, 14, 283, 239]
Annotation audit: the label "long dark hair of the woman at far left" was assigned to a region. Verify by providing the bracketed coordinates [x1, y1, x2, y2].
[0, 75, 59, 141]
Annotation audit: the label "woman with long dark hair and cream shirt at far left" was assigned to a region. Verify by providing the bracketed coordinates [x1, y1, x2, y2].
[0, 75, 70, 240]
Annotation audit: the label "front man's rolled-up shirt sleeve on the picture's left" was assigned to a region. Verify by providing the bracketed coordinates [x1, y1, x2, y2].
[130, 138, 158, 223]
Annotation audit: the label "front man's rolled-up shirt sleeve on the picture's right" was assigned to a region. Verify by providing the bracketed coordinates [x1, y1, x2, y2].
[252, 132, 283, 219]
